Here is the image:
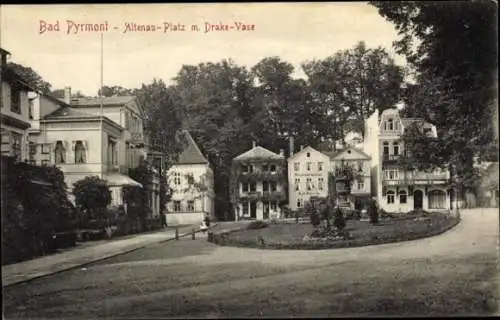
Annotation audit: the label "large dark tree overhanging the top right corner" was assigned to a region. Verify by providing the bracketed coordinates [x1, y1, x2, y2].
[371, 1, 498, 188]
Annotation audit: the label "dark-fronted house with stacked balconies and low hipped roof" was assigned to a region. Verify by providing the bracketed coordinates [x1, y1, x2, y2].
[230, 142, 287, 220]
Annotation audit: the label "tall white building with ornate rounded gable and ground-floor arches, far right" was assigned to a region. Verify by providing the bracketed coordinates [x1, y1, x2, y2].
[364, 108, 452, 212]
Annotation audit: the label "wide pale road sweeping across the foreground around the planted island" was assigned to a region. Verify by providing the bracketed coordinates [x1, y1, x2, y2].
[4, 209, 499, 319]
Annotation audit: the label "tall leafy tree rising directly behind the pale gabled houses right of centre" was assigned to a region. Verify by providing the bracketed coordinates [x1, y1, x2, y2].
[302, 41, 403, 140]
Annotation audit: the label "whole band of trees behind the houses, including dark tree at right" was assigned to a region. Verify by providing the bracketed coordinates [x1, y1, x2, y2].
[13, 1, 498, 218]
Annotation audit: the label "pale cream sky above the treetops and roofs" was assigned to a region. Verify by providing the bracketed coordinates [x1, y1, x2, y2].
[0, 2, 405, 96]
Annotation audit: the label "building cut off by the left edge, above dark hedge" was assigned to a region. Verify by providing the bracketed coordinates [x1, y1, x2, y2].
[0, 48, 34, 161]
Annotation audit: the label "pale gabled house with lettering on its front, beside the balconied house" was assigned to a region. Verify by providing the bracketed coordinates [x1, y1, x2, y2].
[288, 147, 330, 211]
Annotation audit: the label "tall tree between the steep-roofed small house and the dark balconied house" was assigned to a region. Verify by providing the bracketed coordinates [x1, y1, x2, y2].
[174, 60, 252, 218]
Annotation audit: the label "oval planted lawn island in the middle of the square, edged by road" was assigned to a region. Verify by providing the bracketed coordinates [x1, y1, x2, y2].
[209, 213, 459, 249]
